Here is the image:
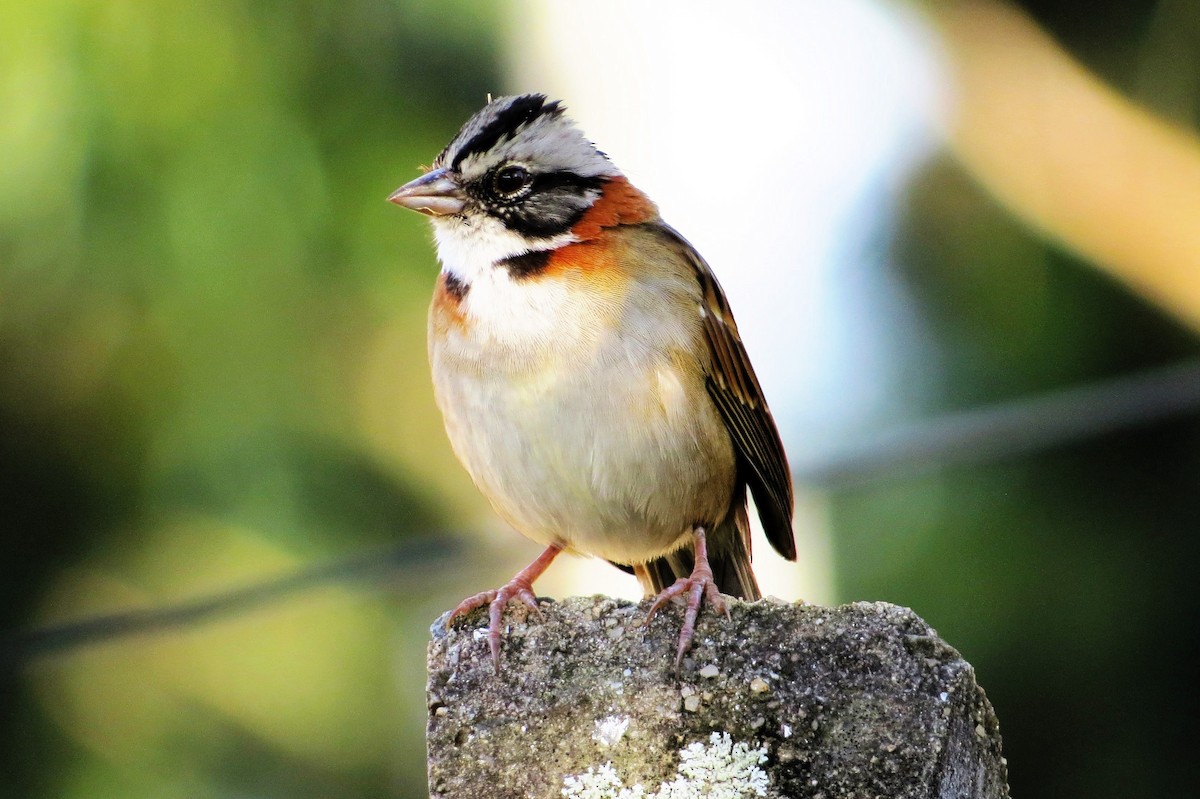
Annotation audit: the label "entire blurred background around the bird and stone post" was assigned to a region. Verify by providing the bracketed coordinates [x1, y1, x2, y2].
[0, 0, 1200, 799]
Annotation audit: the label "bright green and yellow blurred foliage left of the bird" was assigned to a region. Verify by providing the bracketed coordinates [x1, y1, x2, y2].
[0, 0, 499, 798]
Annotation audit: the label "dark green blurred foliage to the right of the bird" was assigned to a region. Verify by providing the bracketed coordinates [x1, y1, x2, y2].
[834, 0, 1200, 799]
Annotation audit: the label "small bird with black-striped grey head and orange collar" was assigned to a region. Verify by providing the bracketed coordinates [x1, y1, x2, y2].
[388, 94, 796, 674]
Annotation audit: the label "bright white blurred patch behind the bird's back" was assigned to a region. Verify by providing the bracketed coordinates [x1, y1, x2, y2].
[505, 0, 943, 602]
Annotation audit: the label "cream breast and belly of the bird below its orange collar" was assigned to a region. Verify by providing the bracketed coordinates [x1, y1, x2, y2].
[430, 233, 734, 563]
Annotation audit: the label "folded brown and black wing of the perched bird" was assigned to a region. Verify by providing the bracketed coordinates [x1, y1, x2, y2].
[662, 224, 796, 560]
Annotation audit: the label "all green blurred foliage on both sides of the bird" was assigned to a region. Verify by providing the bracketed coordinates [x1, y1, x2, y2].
[0, 0, 1200, 799]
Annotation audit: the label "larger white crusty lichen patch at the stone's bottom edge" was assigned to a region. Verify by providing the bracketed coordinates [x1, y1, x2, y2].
[563, 732, 767, 799]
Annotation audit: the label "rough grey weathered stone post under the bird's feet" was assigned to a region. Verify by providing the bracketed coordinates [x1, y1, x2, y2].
[428, 596, 1008, 799]
